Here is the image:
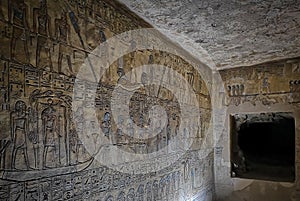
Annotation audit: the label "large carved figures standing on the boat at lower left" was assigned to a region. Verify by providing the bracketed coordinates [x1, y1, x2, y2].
[0, 94, 90, 181]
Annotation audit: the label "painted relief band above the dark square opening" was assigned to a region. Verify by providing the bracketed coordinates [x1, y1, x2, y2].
[220, 59, 300, 106]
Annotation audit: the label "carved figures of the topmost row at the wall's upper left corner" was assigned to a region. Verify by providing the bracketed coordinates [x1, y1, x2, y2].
[0, 0, 106, 75]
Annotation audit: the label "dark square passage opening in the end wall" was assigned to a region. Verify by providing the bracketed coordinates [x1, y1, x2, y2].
[232, 113, 295, 182]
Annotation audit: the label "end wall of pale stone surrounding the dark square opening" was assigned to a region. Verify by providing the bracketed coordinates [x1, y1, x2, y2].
[214, 58, 300, 201]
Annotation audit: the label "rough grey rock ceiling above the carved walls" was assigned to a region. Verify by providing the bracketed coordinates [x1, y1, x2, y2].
[119, 0, 300, 69]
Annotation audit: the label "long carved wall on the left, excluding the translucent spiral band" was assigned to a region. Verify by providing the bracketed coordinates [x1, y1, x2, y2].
[0, 0, 213, 200]
